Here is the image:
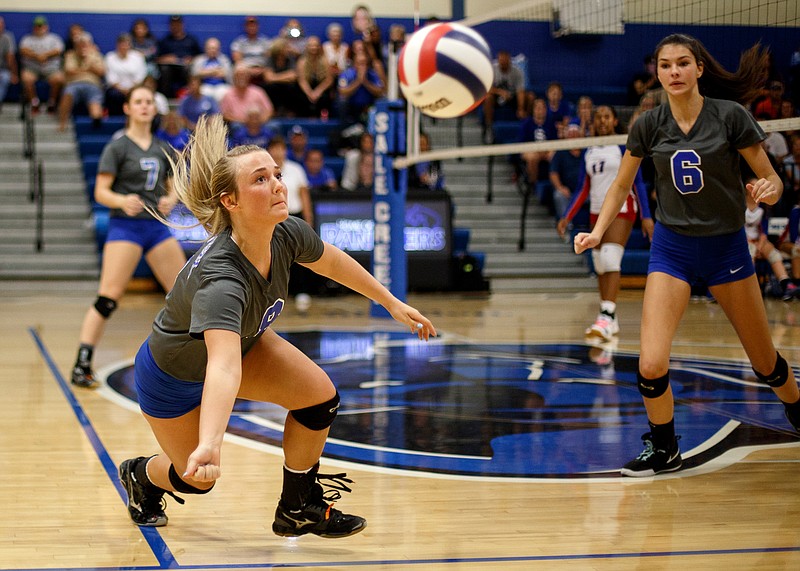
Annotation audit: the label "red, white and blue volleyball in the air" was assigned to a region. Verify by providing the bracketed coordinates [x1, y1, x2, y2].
[397, 23, 494, 118]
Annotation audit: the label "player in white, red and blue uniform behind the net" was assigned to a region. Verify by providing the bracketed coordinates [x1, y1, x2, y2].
[556, 105, 653, 341]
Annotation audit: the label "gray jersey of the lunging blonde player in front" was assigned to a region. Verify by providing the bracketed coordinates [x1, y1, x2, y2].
[149, 217, 324, 381]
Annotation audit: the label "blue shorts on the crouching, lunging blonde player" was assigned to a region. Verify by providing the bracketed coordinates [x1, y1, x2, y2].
[133, 338, 205, 418]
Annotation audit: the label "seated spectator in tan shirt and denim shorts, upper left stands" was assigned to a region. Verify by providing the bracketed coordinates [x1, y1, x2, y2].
[58, 32, 106, 131]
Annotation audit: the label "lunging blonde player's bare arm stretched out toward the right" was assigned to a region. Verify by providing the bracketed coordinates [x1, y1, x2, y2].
[303, 243, 436, 340]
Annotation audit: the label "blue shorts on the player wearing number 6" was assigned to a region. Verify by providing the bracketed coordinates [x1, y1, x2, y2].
[647, 223, 756, 286]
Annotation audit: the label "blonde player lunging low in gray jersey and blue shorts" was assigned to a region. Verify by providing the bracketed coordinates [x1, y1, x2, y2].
[119, 115, 436, 537]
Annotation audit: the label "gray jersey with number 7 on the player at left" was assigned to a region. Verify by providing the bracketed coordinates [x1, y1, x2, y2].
[97, 135, 172, 219]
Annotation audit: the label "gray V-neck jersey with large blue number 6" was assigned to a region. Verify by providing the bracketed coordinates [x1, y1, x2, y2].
[627, 97, 766, 236]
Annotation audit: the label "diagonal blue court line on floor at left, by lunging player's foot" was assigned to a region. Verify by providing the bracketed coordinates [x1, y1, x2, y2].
[28, 327, 178, 569]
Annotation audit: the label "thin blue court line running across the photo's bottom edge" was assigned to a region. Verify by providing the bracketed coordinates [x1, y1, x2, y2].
[7, 546, 800, 571]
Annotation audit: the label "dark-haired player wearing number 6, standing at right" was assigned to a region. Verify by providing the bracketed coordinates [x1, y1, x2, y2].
[574, 34, 800, 477]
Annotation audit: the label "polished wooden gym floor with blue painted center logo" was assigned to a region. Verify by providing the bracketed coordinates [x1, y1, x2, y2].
[0, 285, 800, 571]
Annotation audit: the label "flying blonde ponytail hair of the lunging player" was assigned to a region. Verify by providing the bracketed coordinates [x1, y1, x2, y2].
[167, 114, 264, 236]
